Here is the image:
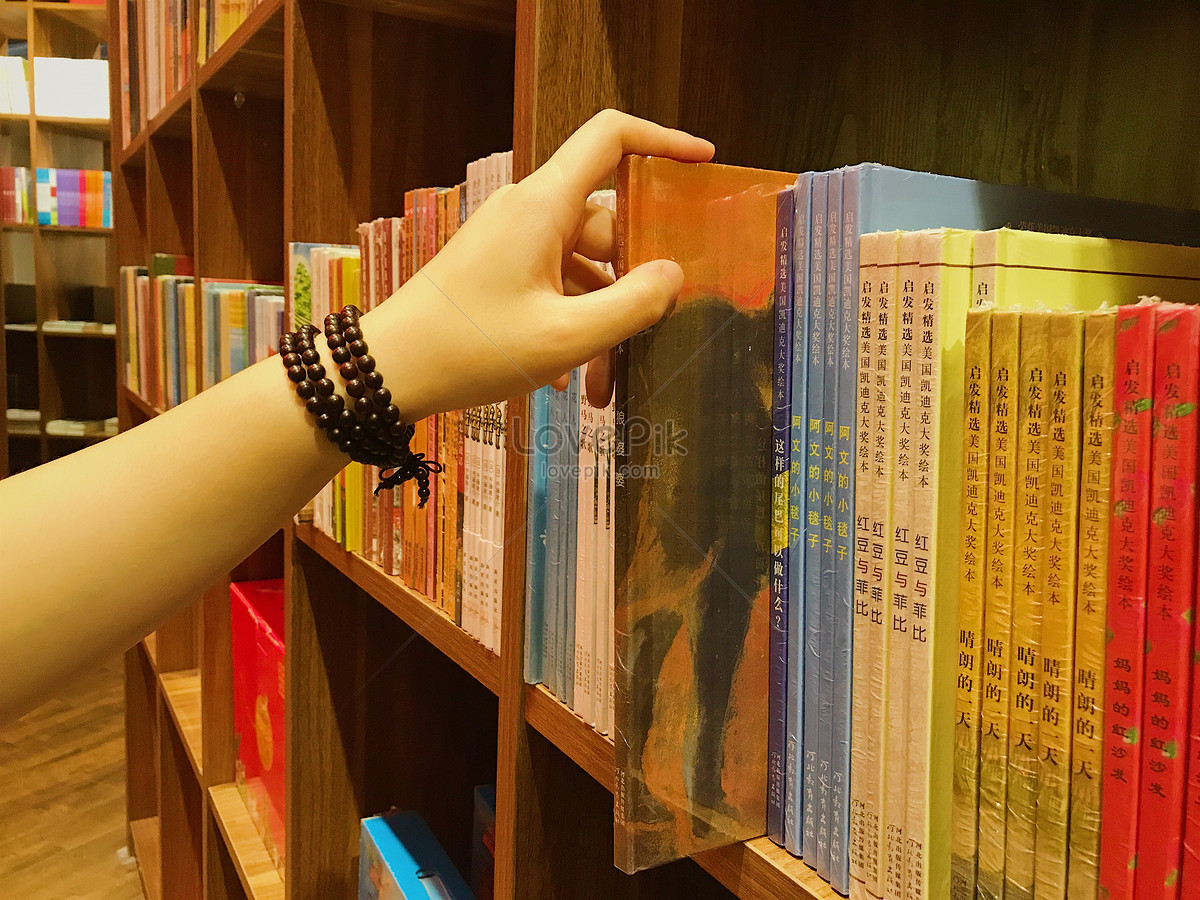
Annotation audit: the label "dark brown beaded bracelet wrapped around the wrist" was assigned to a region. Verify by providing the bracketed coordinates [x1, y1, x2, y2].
[280, 306, 442, 506]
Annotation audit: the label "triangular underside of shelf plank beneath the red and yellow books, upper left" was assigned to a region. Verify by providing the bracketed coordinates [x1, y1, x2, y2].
[198, 0, 283, 100]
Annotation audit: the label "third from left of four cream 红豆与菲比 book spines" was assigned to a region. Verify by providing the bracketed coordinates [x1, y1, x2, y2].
[883, 232, 922, 900]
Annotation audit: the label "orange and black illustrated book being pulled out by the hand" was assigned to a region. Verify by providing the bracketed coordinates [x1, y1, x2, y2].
[614, 157, 794, 872]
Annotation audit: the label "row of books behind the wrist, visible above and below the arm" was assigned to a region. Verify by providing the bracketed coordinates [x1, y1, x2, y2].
[302, 154, 511, 652]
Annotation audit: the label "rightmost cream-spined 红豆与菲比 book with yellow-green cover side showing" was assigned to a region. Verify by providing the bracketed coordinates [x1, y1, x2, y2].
[901, 228, 974, 900]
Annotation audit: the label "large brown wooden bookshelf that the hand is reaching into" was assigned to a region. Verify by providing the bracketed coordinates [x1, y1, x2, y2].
[117, 0, 1200, 900]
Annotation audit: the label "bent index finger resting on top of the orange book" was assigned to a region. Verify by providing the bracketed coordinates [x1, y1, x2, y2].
[530, 109, 714, 206]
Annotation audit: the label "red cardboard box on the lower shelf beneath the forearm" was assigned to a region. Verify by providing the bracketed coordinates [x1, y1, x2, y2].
[229, 578, 286, 871]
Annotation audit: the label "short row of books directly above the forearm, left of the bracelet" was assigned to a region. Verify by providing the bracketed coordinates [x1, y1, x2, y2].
[119, 253, 286, 409]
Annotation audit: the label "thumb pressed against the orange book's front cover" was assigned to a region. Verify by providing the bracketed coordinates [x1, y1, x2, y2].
[571, 259, 683, 359]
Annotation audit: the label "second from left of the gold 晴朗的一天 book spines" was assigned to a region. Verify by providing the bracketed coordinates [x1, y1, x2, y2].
[974, 309, 1021, 900]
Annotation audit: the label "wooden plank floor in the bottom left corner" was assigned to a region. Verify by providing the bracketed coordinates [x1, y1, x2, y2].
[0, 659, 142, 900]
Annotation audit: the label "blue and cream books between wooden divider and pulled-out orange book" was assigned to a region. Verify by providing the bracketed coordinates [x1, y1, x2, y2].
[524, 191, 616, 734]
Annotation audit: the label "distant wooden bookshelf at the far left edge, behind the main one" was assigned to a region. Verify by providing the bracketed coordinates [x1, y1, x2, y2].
[0, 0, 116, 478]
